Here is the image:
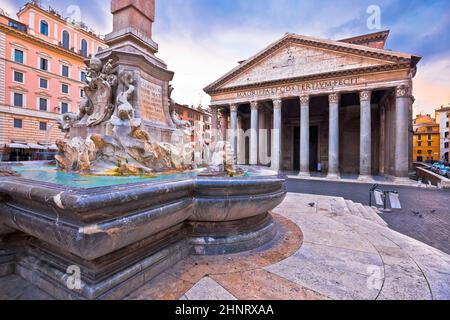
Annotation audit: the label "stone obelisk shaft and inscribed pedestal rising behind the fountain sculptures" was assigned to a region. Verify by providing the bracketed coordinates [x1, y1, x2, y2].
[97, 0, 175, 142]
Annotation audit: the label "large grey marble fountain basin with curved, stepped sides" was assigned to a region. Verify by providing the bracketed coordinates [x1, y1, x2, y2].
[0, 165, 286, 299]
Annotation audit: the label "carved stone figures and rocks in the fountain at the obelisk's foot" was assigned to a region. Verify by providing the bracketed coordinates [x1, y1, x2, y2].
[56, 58, 192, 175]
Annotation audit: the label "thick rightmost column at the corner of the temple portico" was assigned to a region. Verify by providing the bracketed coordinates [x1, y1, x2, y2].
[394, 86, 412, 179]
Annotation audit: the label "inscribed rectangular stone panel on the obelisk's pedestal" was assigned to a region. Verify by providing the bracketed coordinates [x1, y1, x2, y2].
[140, 79, 166, 123]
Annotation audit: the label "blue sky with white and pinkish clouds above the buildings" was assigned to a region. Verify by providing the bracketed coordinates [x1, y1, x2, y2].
[0, 0, 450, 115]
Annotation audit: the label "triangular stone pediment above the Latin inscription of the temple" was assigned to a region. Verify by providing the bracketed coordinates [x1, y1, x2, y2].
[205, 34, 411, 92]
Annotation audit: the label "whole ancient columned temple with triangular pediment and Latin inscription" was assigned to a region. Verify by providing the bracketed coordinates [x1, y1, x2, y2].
[204, 31, 421, 180]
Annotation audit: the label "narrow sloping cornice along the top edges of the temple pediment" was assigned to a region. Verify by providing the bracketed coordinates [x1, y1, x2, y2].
[203, 33, 422, 93]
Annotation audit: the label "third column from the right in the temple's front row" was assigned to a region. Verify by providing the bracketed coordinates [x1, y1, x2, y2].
[327, 93, 340, 179]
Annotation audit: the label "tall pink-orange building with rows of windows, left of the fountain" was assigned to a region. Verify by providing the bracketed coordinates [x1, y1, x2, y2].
[0, 1, 106, 161]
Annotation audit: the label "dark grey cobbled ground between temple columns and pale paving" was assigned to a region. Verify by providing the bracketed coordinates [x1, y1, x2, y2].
[288, 179, 450, 254]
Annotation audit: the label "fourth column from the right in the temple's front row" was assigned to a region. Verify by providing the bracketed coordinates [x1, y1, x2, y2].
[299, 96, 310, 176]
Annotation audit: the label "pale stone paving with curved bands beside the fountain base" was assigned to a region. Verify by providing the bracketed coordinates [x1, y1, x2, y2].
[0, 193, 450, 300]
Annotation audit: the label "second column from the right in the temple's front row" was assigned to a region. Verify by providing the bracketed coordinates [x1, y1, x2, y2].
[359, 90, 372, 181]
